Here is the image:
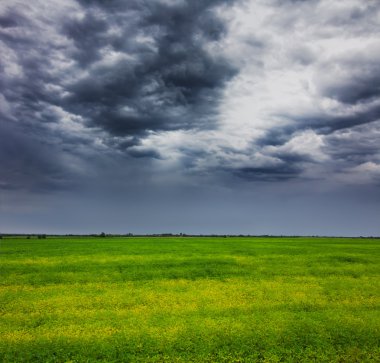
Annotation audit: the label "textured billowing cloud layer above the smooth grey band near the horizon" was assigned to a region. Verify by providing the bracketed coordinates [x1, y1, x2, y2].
[0, 0, 380, 190]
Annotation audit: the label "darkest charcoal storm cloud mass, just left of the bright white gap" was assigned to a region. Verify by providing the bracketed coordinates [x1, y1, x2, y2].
[63, 1, 235, 136]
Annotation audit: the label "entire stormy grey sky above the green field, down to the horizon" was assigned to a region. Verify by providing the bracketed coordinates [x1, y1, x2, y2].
[0, 0, 380, 236]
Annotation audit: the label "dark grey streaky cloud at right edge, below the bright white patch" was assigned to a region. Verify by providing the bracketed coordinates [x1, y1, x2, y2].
[240, 101, 380, 181]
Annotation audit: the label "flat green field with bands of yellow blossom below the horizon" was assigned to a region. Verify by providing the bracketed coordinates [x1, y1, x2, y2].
[0, 237, 380, 363]
